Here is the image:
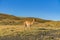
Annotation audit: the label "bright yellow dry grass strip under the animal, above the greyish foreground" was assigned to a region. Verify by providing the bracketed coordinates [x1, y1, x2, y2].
[0, 24, 60, 36]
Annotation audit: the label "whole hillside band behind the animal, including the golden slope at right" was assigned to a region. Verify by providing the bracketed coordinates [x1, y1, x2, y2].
[0, 13, 60, 27]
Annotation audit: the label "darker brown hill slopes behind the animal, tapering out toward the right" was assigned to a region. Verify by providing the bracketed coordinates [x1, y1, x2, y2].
[0, 13, 51, 25]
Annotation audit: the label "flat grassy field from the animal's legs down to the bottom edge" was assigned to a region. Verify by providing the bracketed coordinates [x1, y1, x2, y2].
[0, 25, 60, 40]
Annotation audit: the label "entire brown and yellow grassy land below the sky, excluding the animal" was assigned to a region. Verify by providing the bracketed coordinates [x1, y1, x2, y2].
[0, 13, 60, 40]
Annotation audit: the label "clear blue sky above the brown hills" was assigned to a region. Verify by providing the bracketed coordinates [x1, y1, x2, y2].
[0, 0, 60, 20]
